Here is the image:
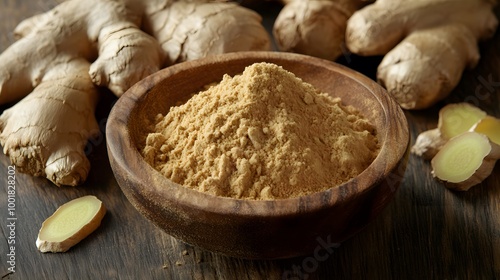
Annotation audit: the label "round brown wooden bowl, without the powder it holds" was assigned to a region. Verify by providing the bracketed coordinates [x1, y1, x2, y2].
[106, 52, 409, 259]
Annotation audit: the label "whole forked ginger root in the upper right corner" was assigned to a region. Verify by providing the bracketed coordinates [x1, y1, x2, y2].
[346, 0, 498, 109]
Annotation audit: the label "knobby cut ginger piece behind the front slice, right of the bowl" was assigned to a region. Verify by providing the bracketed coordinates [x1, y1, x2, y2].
[411, 102, 487, 160]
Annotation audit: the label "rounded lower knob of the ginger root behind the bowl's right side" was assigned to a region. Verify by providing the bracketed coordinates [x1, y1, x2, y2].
[377, 25, 480, 110]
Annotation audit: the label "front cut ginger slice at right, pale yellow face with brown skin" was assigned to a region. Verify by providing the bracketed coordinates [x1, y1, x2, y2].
[431, 132, 500, 191]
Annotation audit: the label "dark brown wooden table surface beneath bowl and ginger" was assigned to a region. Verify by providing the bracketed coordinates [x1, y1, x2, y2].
[0, 0, 500, 280]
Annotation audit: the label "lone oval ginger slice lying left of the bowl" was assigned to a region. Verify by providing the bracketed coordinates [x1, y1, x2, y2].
[36, 195, 106, 253]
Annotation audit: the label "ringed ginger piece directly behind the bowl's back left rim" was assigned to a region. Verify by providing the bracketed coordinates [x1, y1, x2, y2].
[143, 0, 271, 65]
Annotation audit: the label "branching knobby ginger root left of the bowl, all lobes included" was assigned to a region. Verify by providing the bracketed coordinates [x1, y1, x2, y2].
[0, 0, 162, 186]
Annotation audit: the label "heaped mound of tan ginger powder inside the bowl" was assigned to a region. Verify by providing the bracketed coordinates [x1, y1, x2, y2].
[142, 63, 379, 200]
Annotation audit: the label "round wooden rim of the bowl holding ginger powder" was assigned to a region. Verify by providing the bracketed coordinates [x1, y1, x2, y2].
[106, 51, 409, 217]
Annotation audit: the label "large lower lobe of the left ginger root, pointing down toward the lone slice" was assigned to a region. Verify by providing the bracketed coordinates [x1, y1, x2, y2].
[0, 58, 100, 186]
